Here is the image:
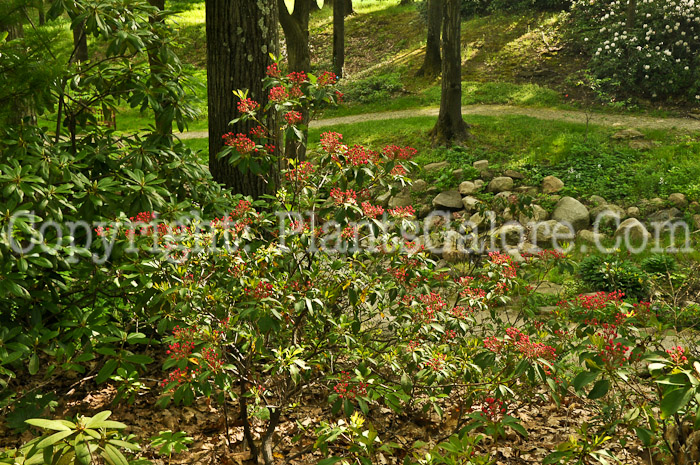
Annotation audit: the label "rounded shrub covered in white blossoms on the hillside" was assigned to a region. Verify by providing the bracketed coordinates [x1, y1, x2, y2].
[572, 0, 700, 100]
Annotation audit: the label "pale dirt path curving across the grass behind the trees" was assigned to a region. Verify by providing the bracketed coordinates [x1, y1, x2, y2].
[180, 105, 700, 139]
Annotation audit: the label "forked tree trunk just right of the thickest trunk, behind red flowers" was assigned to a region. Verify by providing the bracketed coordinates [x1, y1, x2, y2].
[277, 0, 316, 160]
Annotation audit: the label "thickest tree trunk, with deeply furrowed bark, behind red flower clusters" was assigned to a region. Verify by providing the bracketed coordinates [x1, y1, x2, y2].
[206, 0, 279, 198]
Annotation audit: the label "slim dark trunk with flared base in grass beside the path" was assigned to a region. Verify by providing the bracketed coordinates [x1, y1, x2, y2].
[431, 0, 469, 144]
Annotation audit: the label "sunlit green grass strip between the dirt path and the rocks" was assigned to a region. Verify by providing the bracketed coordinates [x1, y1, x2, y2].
[310, 116, 700, 204]
